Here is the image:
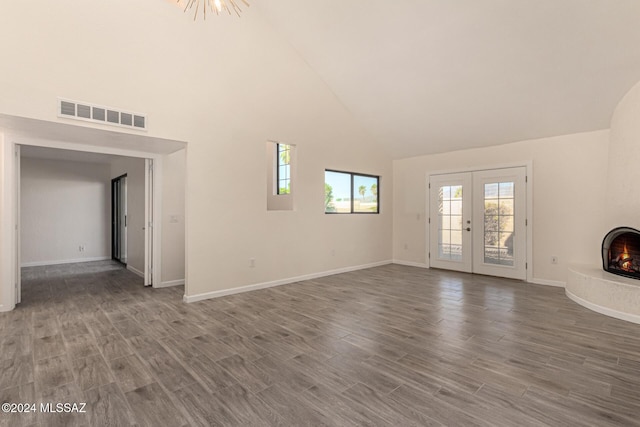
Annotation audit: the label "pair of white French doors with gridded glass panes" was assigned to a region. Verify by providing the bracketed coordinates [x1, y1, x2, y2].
[429, 167, 527, 280]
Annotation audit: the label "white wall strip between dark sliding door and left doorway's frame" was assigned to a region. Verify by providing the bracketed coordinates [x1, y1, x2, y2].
[109, 157, 145, 274]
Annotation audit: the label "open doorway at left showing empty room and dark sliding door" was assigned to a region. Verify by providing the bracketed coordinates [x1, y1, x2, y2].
[16, 145, 154, 304]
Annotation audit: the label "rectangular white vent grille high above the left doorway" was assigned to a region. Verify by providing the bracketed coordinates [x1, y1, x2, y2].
[58, 99, 147, 130]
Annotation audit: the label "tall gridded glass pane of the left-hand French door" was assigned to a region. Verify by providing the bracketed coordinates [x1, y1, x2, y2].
[438, 185, 462, 261]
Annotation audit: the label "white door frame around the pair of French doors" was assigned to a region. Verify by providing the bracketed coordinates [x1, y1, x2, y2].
[425, 160, 534, 283]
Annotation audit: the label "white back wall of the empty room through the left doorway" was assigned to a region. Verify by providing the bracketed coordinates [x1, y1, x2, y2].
[20, 157, 111, 266]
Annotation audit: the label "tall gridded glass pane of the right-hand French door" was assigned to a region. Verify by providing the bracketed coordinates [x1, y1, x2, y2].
[484, 181, 515, 266]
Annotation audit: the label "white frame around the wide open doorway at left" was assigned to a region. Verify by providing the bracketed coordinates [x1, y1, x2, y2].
[0, 134, 168, 312]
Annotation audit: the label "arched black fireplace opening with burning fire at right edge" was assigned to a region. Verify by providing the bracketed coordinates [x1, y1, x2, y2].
[602, 227, 640, 280]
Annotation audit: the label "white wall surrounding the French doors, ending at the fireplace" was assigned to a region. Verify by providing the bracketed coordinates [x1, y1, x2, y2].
[393, 130, 609, 282]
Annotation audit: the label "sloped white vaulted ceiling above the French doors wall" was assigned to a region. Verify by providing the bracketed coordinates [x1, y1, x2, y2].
[256, 0, 640, 158]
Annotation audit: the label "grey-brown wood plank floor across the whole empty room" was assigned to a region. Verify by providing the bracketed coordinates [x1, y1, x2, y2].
[0, 262, 640, 427]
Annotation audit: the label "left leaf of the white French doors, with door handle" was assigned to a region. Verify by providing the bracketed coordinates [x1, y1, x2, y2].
[429, 173, 473, 273]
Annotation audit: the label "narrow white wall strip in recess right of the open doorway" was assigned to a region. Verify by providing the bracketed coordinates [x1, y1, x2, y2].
[162, 150, 186, 284]
